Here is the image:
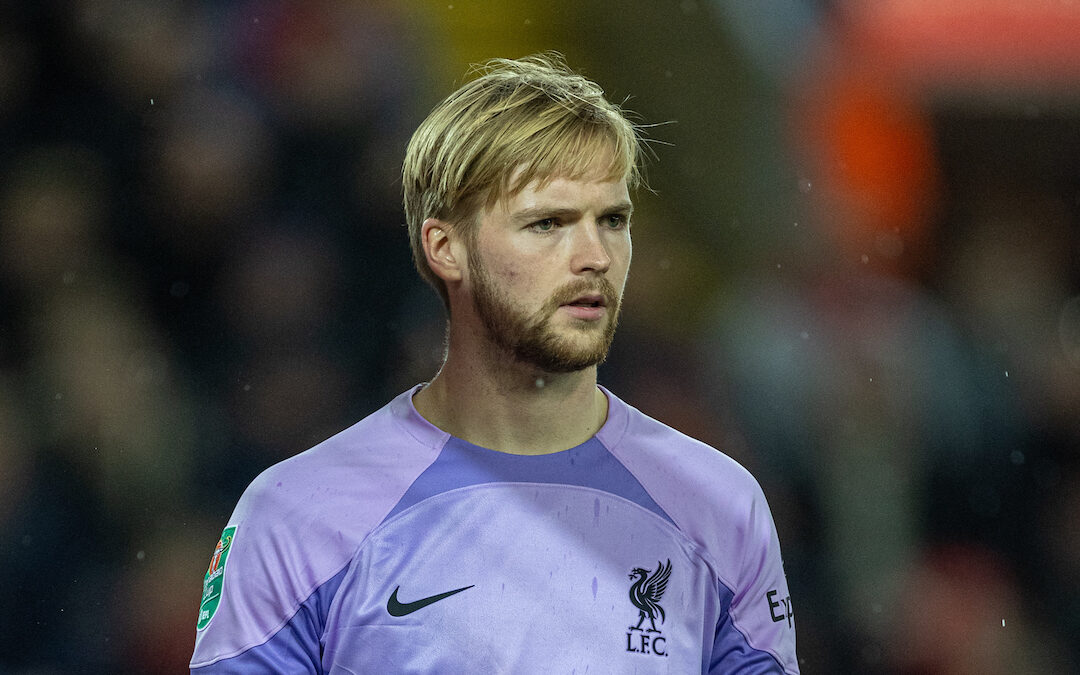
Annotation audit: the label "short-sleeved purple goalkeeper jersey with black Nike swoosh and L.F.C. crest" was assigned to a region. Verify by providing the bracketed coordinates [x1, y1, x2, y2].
[191, 389, 799, 675]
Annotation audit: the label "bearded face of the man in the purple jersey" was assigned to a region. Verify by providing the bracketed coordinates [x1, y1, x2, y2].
[468, 170, 633, 373]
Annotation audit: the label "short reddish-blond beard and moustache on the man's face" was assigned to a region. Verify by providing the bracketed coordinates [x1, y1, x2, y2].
[469, 249, 620, 373]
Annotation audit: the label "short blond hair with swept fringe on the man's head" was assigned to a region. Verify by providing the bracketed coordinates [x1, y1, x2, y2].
[402, 53, 642, 309]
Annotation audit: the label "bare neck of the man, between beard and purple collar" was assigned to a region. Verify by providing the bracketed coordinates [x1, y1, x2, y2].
[413, 319, 608, 455]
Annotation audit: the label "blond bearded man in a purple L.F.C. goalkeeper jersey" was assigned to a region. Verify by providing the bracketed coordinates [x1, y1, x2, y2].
[191, 56, 798, 673]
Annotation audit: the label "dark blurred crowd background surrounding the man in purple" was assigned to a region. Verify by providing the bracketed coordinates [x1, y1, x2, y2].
[0, 0, 1080, 675]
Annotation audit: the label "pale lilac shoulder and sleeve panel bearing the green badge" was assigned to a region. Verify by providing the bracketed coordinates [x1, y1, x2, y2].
[192, 392, 441, 664]
